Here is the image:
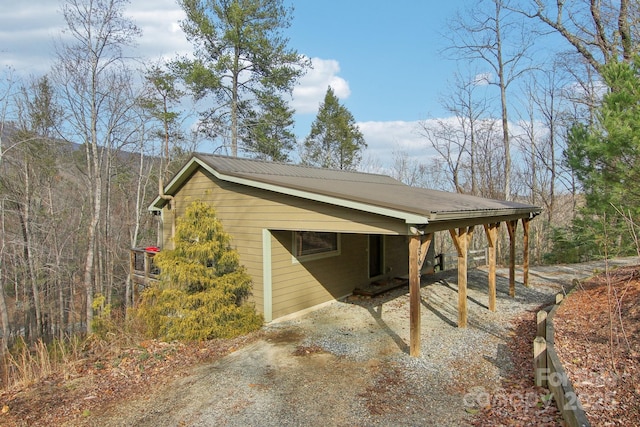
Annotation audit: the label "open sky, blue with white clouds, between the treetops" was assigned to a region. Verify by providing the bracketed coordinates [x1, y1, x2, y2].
[0, 0, 472, 164]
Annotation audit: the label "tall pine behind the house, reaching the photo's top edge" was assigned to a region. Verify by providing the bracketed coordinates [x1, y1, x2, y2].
[176, 0, 308, 156]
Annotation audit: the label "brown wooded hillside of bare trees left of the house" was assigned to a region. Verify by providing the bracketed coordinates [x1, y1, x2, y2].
[0, 123, 160, 341]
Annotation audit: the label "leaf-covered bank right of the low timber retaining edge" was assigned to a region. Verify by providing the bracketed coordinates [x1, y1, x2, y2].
[554, 267, 640, 426]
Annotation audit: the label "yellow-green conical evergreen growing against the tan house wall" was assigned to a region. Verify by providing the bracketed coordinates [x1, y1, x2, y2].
[138, 201, 262, 340]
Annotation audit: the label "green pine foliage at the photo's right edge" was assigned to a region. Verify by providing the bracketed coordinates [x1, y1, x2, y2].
[565, 56, 640, 255]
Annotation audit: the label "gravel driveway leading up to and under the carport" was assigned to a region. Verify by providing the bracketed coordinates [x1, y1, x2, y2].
[94, 259, 637, 426]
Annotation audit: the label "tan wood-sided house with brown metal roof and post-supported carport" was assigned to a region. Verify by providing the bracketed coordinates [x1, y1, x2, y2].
[149, 154, 540, 354]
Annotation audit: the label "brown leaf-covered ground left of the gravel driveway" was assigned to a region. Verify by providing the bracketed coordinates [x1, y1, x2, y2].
[0, 334, 257, 426]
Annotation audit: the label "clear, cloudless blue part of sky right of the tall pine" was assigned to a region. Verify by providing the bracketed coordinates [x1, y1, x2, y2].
[290, 0, 456, 121]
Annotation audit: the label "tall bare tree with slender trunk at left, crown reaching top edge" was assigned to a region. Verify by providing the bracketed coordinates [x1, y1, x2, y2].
[54, 0, 140, 333]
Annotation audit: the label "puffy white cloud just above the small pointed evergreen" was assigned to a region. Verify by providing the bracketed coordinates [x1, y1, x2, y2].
[291, 58, 351, 114]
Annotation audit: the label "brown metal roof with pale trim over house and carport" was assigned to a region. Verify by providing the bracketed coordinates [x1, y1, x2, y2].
[150, 154, 541, 224]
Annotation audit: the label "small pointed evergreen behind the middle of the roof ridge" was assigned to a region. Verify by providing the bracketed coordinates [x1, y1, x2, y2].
[302, 87, 367, 170]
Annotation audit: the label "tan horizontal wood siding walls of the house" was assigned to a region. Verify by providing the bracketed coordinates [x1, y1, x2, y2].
[162, 169, 408, 319]
